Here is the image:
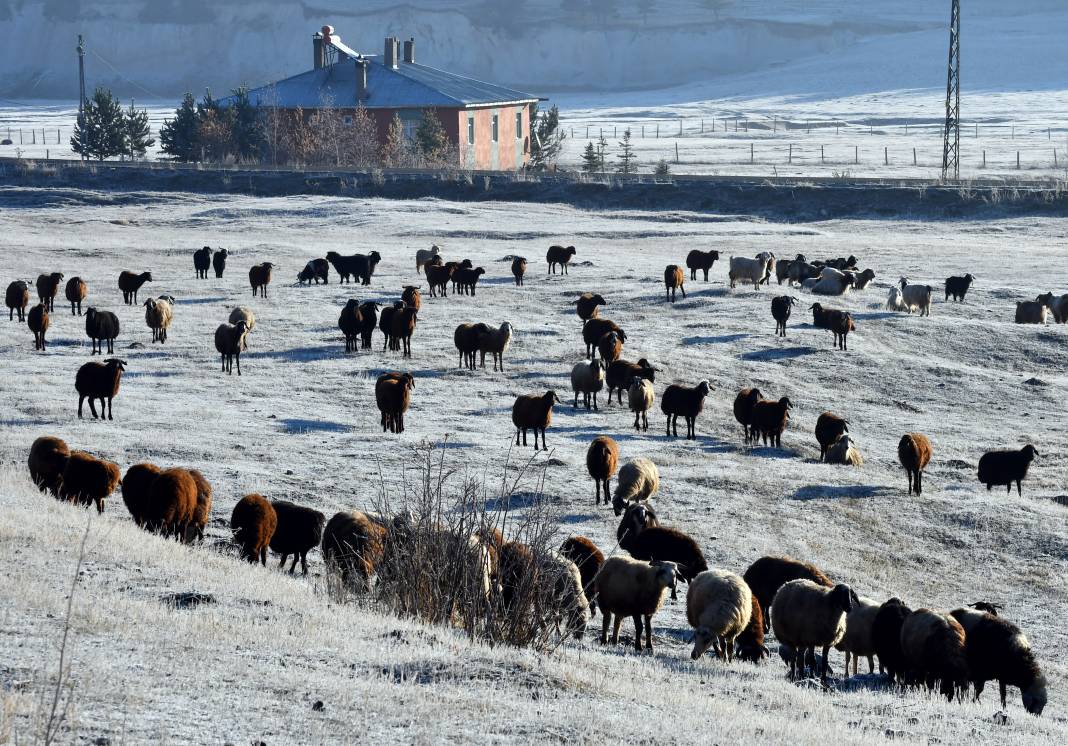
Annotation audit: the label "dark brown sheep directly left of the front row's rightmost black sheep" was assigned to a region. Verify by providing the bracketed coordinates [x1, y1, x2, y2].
[901, 608, 969, 701]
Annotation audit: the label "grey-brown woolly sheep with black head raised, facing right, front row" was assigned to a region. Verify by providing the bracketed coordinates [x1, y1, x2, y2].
[771, 580, 857, 681]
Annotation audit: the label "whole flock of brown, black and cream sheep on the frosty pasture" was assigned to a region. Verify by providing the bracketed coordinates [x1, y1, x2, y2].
[6, 241, 1068, 714]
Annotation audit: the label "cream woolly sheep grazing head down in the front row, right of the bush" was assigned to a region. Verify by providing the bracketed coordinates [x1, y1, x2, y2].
[686, 570, 753, 663]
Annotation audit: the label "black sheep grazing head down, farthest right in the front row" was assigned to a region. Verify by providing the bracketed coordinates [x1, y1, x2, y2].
[949, 609, 1047, 715]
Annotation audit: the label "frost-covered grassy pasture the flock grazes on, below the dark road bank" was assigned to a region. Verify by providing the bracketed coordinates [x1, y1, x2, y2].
[0, 188, 1068, 744]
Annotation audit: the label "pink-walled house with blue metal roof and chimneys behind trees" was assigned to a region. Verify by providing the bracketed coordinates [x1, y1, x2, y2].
[223, 26, 539, 171]
